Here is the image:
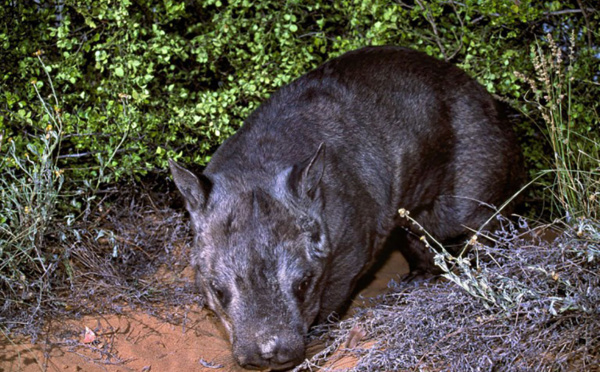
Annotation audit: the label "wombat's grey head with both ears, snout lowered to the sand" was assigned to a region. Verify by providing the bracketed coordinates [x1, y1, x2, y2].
[170, 148, 329, 370]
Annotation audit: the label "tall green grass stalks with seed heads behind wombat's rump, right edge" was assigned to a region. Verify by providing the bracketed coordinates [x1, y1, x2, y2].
[515, 34, 600, 221]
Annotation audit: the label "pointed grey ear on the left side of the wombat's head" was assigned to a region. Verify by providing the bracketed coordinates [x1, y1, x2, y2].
[169, 159, 212, 213]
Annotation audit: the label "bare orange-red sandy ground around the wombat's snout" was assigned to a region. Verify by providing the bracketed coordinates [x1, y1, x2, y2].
[0, 252, 408, 372]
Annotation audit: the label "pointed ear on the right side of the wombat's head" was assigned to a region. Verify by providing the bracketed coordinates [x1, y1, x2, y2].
[289, 142, 325, 200]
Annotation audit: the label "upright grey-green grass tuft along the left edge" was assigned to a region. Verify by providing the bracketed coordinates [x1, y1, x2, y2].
[0, 55, 69, 326]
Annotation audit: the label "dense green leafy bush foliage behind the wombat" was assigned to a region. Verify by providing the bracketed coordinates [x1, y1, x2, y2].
[0, 0, 600, 192]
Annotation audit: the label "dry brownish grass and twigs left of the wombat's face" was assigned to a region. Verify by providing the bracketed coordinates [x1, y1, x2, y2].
[0, 188, 203, 340]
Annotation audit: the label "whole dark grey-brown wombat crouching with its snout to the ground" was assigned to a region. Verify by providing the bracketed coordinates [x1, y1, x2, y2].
[170, 47, 521, 370]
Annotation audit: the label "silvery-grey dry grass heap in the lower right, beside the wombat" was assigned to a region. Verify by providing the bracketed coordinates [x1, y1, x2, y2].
[295, 220, 600, 371]
